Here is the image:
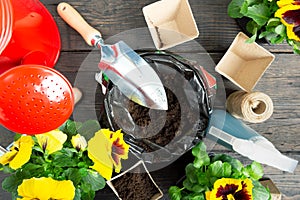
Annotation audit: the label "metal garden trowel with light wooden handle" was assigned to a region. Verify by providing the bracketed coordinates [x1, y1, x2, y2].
[57, 3, 168, 110]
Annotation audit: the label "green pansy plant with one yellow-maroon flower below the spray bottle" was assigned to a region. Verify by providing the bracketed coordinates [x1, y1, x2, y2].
[169, 142, 271, 200]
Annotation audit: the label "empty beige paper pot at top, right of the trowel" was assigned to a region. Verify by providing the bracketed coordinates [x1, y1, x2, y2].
[143, 0, 199, 50]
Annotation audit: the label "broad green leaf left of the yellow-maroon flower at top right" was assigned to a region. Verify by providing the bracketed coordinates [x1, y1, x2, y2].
[247, 4, 271, 26]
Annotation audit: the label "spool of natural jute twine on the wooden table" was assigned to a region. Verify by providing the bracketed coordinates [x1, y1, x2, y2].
[226, 91, 273, 123]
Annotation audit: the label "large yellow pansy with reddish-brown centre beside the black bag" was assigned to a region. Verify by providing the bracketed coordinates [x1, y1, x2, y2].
[88, 129, 129, 180]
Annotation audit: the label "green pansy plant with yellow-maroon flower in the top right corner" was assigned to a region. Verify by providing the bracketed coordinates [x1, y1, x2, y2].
[228, 0, 300, 54]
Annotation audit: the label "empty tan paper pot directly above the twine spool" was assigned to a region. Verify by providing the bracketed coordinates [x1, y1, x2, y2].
[215, 32, 275, 92]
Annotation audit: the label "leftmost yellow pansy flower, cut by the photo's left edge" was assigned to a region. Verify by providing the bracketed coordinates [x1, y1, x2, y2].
[0, 136, 34, 170]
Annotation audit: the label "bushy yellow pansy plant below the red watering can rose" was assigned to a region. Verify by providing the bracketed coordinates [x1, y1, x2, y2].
[0, 120, 129, 200]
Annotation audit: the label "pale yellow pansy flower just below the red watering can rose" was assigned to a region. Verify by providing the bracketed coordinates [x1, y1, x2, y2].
[35, 130, 68, 154]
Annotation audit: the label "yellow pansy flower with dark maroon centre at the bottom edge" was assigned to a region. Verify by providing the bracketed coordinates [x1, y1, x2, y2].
[205, 178, 253, 200]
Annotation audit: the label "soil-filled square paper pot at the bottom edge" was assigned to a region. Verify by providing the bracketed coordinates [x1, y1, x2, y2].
[106, 160, 163, 200]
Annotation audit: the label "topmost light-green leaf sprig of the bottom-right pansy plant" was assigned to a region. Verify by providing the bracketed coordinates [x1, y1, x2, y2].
[192, 142, 210, 168]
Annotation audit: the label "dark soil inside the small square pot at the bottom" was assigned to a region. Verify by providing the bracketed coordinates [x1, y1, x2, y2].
[112, 165, 159, 200]
